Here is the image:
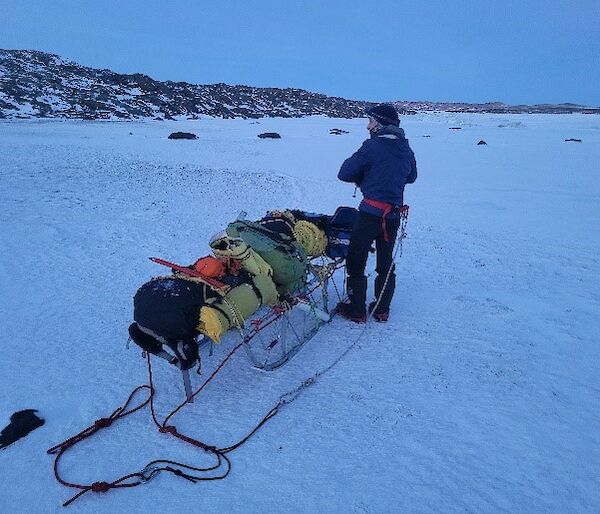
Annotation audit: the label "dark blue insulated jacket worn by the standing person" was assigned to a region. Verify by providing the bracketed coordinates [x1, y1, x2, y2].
[338, 125, 417, 216]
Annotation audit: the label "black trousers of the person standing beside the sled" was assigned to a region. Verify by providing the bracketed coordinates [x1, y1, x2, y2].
[346, 212, 400, 316]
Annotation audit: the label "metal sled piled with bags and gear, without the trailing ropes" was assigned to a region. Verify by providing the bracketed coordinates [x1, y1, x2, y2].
[129, 207, 357, 400]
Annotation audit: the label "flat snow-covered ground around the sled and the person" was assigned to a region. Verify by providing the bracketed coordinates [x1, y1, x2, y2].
[0, 114, 600, 513]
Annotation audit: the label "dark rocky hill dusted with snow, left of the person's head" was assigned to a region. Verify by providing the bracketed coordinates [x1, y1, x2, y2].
[0, 50, 370, 119]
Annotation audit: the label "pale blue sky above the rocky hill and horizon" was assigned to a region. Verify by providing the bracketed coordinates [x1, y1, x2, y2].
[0, 0, 600, 106]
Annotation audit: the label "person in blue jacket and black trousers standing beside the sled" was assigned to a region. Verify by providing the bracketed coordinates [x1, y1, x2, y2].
[337, 104, 417, 323]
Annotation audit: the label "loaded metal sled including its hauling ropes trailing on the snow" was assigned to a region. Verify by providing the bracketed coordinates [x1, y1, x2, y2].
[48, 202, 408, 506]
